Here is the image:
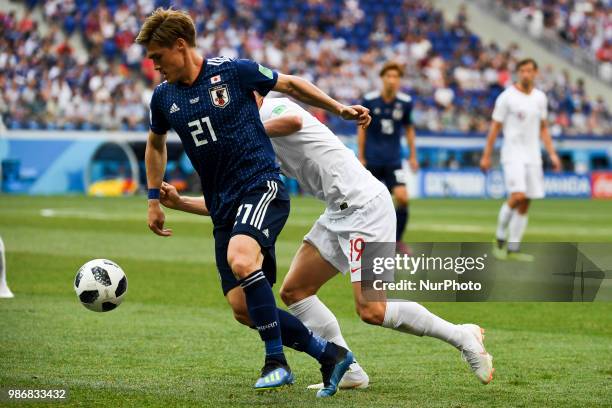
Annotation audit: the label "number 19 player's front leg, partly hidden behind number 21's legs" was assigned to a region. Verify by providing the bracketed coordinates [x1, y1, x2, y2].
[280, 242, 369, 389]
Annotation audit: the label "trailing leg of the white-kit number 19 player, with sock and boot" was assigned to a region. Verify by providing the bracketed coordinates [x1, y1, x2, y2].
[353, 282, 494, 384]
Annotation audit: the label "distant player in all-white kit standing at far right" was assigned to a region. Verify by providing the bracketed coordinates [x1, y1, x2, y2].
[480, 58, 561, 261]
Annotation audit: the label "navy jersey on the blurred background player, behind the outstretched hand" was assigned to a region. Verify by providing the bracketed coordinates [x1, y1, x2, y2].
[362, 92, 412, 166]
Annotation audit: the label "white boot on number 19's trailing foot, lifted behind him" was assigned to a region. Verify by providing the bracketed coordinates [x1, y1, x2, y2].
[459, 324, 495, 384]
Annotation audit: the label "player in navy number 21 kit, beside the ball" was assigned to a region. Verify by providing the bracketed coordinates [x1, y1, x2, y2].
[136, 8, 370, 397]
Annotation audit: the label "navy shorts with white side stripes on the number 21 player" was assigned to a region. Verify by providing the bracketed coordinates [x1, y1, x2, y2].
[213, 180, 290, 296]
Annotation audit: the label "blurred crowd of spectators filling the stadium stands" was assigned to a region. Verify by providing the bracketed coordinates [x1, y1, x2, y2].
[0, 0, 612, 135]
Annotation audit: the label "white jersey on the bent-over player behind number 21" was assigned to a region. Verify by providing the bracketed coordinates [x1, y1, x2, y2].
[259, 98, 387, 215]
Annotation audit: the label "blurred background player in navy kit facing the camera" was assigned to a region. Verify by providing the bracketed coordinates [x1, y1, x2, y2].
[357, 61, 419, 253]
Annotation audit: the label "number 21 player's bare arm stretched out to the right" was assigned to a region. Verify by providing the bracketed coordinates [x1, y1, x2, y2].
[272, 74, 372, 128]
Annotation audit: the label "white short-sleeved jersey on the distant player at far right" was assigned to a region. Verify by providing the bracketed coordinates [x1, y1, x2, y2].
[493, 85, 548, 164]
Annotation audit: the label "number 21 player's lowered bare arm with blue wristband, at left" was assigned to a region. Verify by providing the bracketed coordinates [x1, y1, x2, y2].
[145, 131, 172, 237]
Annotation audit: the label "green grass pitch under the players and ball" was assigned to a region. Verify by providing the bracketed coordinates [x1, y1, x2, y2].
[0, 196, 612, 407]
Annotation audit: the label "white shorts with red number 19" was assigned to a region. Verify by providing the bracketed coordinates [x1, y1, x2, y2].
[304, 190, 397, 282]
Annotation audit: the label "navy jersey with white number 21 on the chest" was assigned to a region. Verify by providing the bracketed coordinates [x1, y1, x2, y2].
[150, 57, 279, 225]
